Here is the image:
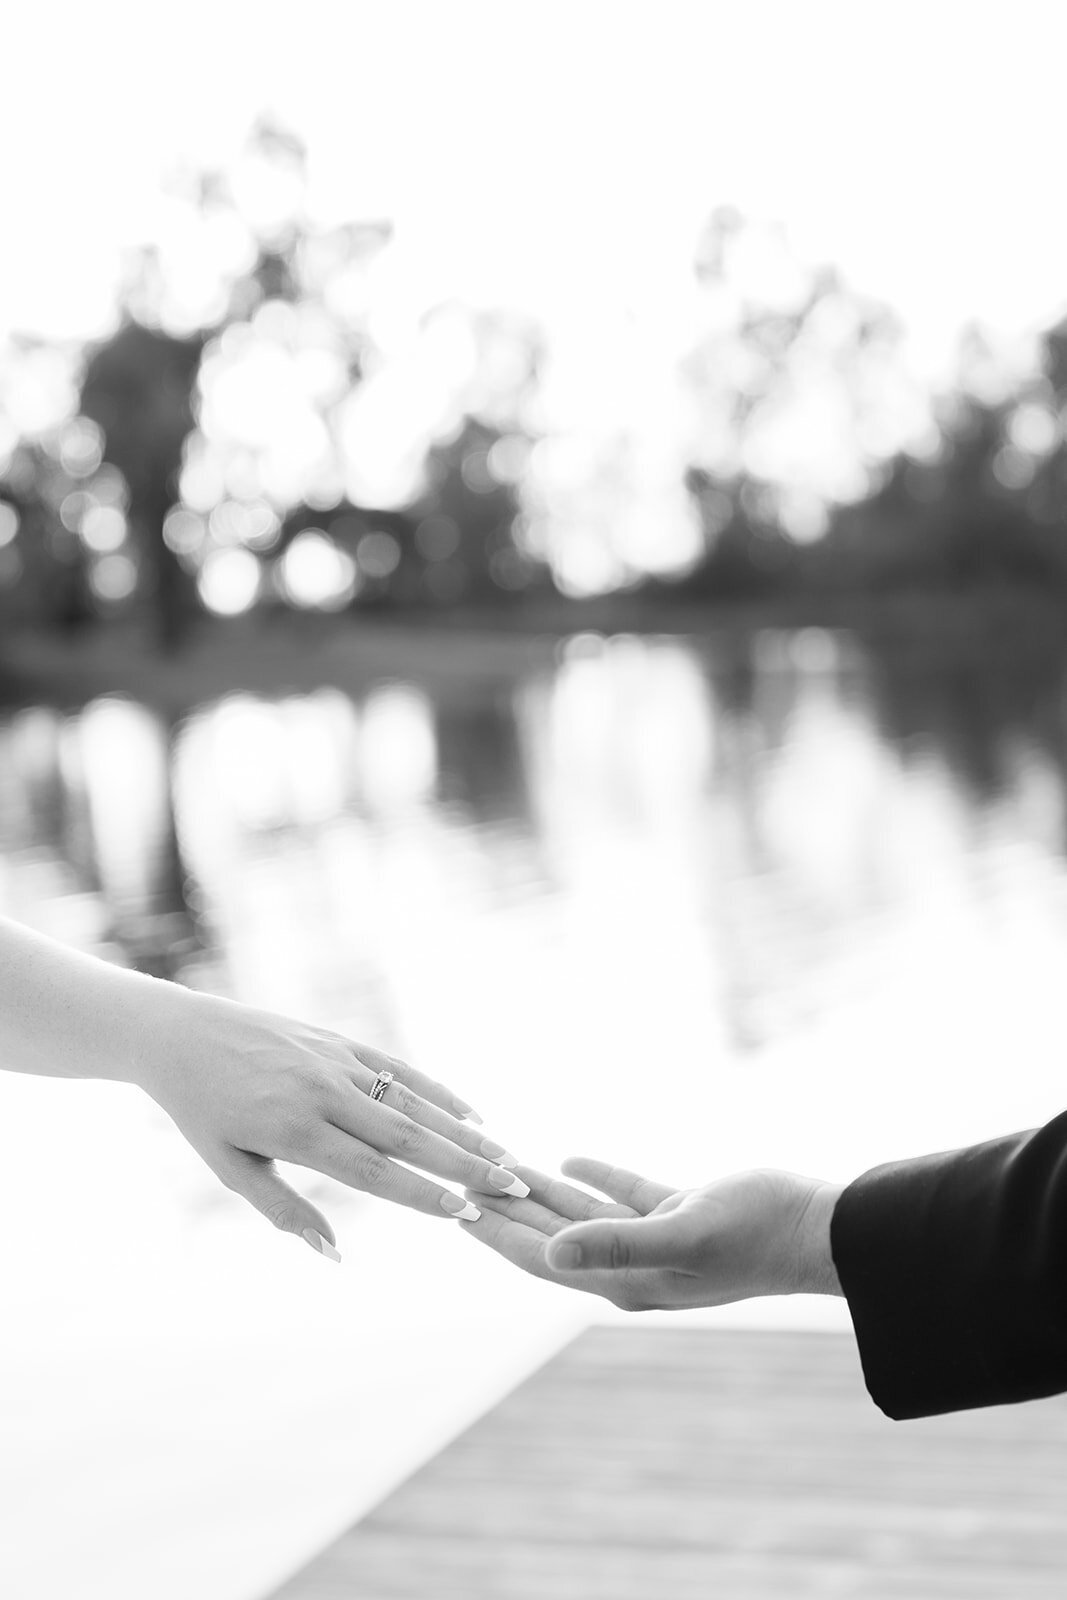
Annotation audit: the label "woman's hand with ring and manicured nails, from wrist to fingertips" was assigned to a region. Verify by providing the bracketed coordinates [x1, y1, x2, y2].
[128, 984, 528, 1259]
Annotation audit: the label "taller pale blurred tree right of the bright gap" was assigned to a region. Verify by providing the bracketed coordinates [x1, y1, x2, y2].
[683, 208, 926, 594]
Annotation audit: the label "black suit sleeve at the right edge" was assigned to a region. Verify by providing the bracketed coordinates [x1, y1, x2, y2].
[830, 1112, 1067, 1419]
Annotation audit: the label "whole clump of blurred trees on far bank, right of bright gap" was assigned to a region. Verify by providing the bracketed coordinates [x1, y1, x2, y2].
[677, 211, 1067, 597]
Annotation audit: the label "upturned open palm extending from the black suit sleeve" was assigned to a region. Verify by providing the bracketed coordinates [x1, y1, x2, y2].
[464, 1158, 841, 1310]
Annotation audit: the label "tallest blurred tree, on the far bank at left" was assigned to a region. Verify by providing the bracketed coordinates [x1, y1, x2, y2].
[67, 118, 399, 646]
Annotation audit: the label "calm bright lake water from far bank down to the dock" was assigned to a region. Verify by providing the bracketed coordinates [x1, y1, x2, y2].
[0, 629, 1067, 1600]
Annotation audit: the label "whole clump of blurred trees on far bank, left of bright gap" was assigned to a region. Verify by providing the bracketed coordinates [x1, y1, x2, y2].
[0, 122, 547, 648]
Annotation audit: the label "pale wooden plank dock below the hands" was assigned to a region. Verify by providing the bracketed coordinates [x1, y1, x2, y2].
[265, 1326, 1067, 1600]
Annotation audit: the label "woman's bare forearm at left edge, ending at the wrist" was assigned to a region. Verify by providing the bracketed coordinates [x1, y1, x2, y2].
[0, 918, 170, 1082]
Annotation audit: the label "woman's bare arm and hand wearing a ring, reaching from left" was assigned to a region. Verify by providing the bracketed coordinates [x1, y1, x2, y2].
[0, 918, 530, 1256]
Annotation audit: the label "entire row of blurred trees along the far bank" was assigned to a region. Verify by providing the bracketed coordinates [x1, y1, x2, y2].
[0, 131, 1067, 648]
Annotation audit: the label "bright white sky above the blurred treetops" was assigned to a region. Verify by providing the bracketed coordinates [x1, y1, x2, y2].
[8, 0, 1067, 361]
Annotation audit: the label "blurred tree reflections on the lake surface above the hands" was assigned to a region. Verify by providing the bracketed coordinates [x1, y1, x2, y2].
[0, 629, 1067, 1050]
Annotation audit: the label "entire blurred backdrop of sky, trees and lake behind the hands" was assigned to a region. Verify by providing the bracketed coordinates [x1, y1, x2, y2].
[0, 0, 1067, 1600]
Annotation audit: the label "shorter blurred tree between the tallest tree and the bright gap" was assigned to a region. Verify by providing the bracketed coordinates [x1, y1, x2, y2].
[270, 302, 545, 608]
